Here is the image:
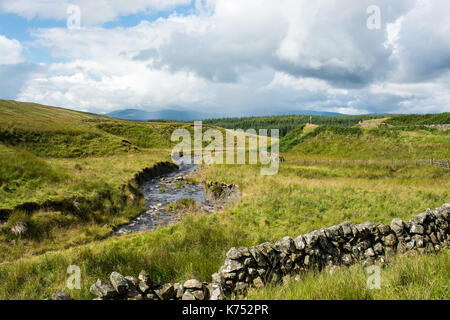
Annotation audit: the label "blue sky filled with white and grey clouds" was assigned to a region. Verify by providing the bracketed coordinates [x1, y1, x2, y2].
[0, 0, 450, 116]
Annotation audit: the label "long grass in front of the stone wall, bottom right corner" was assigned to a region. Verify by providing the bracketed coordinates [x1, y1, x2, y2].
[248, 251, 450, 300]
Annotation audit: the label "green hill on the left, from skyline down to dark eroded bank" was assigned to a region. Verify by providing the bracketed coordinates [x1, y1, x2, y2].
[0, 100, 203, 209]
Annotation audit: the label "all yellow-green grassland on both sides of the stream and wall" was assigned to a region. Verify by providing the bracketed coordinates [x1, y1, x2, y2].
[0, 101, 450, 299]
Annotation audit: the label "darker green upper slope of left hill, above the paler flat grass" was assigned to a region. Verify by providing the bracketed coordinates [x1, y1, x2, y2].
[0, 100, 202, 158]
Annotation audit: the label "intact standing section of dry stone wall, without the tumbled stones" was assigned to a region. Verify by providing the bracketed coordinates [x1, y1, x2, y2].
[213, 204, 450, 297]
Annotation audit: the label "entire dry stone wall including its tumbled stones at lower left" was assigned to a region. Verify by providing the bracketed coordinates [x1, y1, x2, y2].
[52, 204, 450, 300]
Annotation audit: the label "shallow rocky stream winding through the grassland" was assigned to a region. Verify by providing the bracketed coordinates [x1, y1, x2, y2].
[114, 161, 214, 235]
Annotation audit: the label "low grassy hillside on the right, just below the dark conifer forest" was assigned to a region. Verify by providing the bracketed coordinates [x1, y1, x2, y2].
[280, 126, 450, 160]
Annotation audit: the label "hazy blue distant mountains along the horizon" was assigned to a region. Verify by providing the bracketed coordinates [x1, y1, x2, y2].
[106, 109, 345, 121]
